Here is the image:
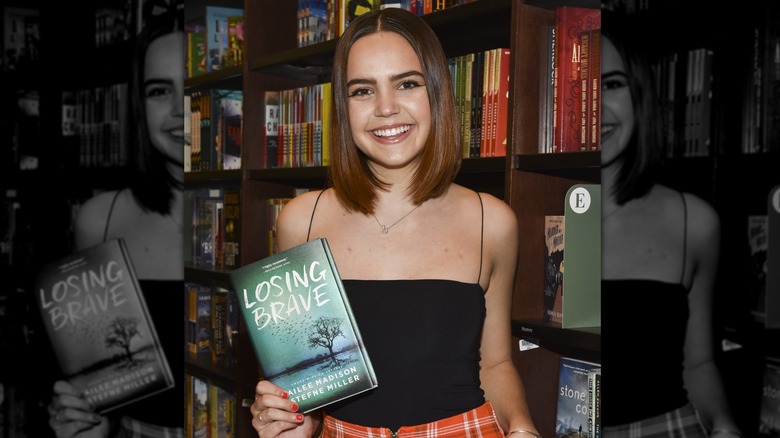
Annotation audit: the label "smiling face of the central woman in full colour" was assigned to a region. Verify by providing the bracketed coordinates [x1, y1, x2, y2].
[347, 32, 431, 169]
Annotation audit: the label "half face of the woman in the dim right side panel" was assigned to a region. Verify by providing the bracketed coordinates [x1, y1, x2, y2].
[601, 38, 635, 164]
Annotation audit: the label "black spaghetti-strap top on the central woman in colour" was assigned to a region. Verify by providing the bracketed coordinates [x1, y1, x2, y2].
[307, 190, 485, 430]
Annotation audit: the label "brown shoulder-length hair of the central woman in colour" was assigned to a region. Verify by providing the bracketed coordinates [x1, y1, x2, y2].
[329, 8, 462, 214]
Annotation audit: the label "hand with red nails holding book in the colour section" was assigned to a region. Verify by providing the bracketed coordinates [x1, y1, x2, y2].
[249, 380, 322, 438]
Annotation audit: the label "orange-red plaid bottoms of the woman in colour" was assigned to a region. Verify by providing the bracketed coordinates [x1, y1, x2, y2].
[320, 402, 504, 438]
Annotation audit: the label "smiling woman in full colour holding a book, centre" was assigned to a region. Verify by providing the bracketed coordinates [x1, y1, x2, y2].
[251, 8, 538, 438]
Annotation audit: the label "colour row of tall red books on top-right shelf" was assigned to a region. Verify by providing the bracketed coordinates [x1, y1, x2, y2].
[538, 6, 601, 153]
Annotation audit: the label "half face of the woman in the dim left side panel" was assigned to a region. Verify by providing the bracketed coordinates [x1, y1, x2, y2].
[143, 32, 185, 164]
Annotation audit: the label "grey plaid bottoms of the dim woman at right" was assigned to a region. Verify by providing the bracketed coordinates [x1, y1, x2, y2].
[601, 403, 707, 438]
